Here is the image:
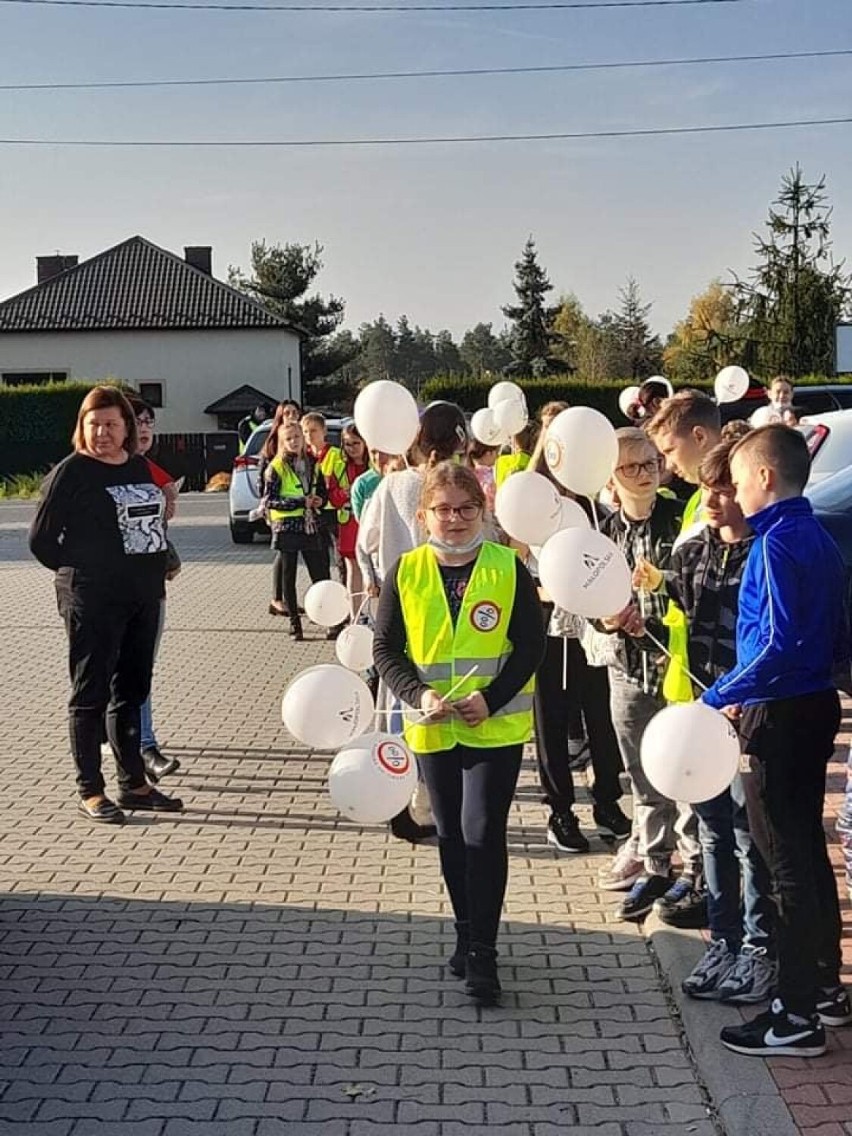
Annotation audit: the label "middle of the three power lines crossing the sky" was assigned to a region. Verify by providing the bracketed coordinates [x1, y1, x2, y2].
[0, 48, 852, 91]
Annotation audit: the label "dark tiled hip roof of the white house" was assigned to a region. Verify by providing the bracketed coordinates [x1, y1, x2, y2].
[0, 236, 298, 334]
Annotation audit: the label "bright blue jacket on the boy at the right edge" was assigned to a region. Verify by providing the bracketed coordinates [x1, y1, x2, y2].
[702, 496, 849, 709]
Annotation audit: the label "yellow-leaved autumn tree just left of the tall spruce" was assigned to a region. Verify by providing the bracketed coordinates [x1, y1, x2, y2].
[662, 279, 743, 384]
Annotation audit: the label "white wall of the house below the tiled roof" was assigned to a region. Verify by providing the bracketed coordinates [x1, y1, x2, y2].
[0, 328, 301, 434]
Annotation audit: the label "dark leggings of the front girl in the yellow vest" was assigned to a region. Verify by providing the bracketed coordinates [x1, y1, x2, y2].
[417, 745, 524, 947]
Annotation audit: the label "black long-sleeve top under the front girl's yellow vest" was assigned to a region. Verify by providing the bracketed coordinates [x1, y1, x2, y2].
[373, 547, 545, 713]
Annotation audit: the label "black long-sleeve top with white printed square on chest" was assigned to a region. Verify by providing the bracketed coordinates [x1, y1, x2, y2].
[30, 453, 166, 599]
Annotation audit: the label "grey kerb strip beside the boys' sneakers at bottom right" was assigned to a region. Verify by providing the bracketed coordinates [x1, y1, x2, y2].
[645, 914, 799, 1136]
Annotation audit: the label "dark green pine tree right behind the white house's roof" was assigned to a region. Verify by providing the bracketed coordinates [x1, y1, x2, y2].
[228, 241, 352, 383]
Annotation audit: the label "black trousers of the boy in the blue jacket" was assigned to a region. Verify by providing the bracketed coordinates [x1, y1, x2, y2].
[740, 691, 842, 1017]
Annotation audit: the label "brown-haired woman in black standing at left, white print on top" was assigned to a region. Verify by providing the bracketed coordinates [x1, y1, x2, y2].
[30, 386, 183, 825]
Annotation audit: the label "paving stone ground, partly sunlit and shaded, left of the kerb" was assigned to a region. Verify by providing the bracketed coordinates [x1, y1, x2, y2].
[0, 495, 813, 1136]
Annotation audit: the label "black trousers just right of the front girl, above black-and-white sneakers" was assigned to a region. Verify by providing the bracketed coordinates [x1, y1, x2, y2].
[535, 635, 623, 813]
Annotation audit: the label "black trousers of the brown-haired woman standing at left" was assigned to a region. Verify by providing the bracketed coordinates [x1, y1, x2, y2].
[57, 583, 160, 797]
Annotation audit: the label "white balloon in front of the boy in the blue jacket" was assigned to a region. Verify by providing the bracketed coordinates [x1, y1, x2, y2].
[640, 702, 740, 804]
